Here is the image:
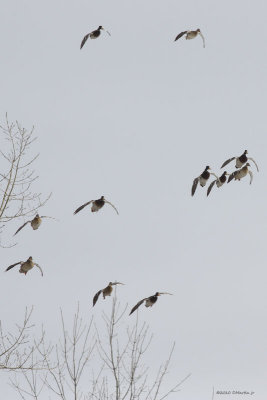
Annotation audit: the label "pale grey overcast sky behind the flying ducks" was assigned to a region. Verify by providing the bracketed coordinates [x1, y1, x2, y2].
[0, 0, 267, 400]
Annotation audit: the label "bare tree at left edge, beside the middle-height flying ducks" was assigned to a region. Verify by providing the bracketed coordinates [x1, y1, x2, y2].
[0, 111, 51, 244]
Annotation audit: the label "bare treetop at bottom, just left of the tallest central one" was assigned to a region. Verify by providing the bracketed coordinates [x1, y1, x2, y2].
[11, 305, 96, 400]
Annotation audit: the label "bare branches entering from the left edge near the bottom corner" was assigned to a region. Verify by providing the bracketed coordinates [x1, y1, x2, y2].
[0, 308, 49, 371]
